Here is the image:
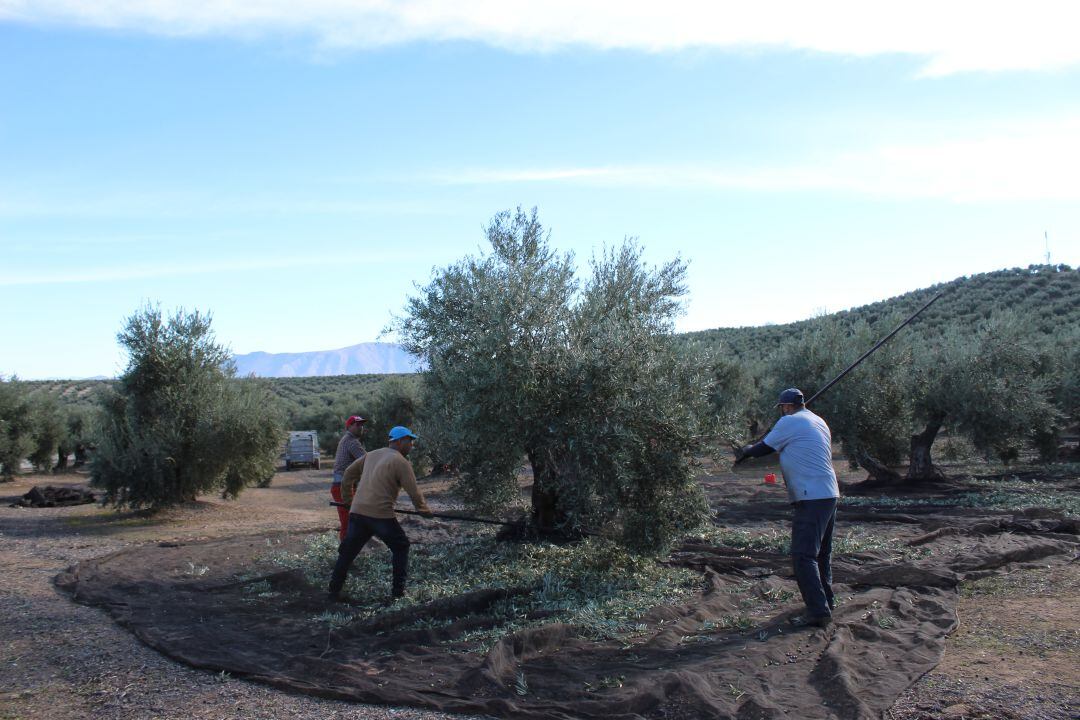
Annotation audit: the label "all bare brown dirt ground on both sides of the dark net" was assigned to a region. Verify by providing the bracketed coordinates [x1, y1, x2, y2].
[0, 467, 1080, 720]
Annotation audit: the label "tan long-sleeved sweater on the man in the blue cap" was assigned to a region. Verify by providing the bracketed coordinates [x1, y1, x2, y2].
[341, 448, 431, 519]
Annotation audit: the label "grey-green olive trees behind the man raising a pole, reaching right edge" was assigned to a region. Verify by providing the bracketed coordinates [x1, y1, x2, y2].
[712, 306, 1080, 481]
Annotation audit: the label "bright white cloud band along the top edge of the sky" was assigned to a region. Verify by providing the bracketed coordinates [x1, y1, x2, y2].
[0, 0, 1080, 76]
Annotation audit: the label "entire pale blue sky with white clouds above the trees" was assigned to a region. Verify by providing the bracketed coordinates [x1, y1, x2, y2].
[0, 0, 1080, 379]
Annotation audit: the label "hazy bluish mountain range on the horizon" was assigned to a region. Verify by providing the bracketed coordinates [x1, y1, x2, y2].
[233, 342, 424, 378]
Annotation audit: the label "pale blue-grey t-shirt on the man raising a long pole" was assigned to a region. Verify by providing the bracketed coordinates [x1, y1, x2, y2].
[764, 409, 840, 502]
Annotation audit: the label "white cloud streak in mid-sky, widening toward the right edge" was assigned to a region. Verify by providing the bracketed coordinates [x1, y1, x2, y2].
[434, 118, 1080, 203]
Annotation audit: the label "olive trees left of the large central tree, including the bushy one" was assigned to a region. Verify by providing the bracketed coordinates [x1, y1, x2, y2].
[0, 334, 430, 498]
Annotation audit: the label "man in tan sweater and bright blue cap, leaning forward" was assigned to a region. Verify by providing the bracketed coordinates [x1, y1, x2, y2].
[329, 425, 431, 601]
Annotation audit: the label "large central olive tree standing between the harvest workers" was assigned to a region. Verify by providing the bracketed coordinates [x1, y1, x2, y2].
[396, 208, 706, 551]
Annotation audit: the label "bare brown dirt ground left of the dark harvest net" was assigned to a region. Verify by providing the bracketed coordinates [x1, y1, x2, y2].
[0, 471, 481, 720]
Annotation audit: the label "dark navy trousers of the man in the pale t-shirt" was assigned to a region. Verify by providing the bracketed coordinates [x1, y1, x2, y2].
[792, 498, 837, 617]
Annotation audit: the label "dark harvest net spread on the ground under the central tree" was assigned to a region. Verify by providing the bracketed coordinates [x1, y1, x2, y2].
[58, 481, 1078, 720]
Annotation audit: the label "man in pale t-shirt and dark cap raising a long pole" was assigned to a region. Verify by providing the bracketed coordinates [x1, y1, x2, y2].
[735, 388, 840, 627]
